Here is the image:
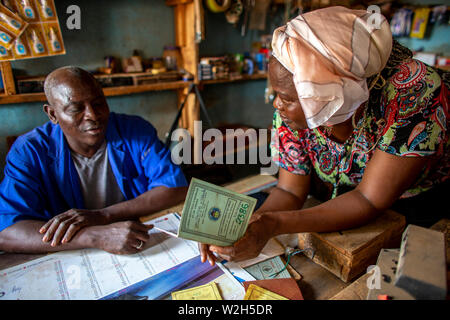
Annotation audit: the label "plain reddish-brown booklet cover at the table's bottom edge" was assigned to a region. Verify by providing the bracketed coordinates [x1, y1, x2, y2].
[243, 278, 304, 300]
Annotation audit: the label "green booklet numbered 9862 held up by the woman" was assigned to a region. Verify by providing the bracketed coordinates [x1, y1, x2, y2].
[178, 178, 256, 246]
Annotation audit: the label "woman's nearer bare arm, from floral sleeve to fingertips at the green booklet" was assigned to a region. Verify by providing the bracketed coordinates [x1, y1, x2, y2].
[209, 150, 428, 261]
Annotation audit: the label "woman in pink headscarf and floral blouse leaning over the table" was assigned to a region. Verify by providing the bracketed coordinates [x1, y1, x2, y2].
[201, 7, 450, 263]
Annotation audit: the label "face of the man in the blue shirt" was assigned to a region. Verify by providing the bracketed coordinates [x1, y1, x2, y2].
[47, 74, 109, 156]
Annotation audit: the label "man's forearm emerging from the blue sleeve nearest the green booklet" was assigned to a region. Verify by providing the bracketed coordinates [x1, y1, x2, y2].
[103, 187, 188, 222]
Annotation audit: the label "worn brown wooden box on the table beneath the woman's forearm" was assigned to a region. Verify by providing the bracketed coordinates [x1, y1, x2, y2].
[298, 210, 405, 282]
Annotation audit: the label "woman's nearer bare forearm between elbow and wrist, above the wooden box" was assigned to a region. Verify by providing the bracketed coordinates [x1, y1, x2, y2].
[267, 190, 380, 235]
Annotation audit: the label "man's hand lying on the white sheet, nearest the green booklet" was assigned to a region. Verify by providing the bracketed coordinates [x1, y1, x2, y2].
[85, 221, 153, 254]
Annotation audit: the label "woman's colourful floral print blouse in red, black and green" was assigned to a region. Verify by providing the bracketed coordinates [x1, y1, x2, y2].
[271, 59, 450, 198]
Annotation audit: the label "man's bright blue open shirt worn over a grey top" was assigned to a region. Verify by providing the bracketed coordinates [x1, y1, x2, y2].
[0, 112, 187, 231]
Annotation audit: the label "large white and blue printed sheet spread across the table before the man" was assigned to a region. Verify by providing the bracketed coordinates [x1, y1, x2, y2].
[0, 213, 245, 300]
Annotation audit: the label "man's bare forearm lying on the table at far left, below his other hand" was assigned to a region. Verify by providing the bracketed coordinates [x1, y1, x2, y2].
[0, 220, 92, 253]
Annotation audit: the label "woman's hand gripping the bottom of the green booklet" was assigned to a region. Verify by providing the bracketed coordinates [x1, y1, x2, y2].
[200, 212, 276, 263]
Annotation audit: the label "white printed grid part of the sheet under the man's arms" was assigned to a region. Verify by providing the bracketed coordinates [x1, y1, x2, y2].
[0, 213, 199, 300]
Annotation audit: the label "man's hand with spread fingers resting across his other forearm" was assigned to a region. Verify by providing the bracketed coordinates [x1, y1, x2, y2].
[39, 209, 109, 247]
